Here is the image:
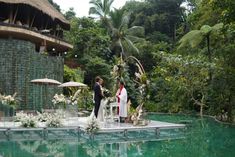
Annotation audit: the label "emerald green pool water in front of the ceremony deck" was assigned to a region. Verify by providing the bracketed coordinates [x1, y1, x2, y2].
[0, 114, 235, 157]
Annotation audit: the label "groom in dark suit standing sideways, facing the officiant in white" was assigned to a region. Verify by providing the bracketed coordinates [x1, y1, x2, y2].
[94, 76, 103, 118]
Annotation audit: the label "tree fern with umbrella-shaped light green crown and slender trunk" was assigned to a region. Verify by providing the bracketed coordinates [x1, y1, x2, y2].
[178, 23, 223, 80]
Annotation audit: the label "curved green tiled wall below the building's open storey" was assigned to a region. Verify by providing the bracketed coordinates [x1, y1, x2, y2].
[0, 39, 64, 110]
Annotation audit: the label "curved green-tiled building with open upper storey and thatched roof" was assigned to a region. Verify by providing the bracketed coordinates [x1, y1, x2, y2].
[0, 0, 73, 112]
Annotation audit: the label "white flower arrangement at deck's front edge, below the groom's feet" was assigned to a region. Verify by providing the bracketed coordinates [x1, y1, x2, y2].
[85, 116, 100, 134]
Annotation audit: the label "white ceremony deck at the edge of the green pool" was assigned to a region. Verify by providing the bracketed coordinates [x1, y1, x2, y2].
[0, 117, 185, 133]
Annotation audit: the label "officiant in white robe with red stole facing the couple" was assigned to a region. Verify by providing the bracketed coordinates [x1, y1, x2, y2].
[116, 80, 127, 123]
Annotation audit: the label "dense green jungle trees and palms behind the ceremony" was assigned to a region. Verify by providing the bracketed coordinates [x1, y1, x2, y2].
[49, 0, 235, 121]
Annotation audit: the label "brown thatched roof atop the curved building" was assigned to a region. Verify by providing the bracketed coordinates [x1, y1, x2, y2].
[0, 0, 70, 28]
